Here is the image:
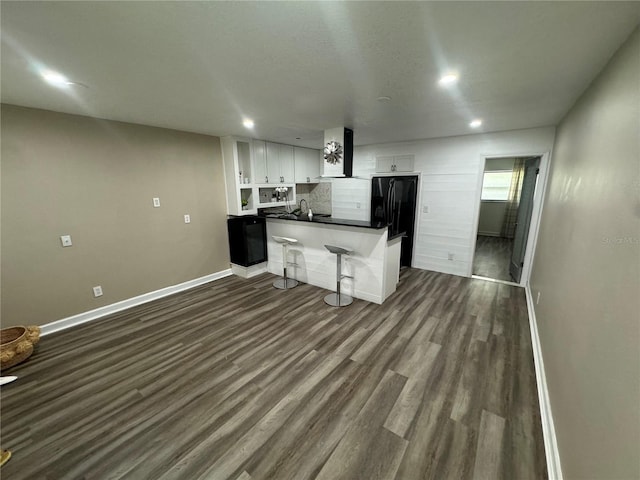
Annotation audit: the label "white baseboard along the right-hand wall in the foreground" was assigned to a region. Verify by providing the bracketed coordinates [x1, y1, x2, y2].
[524, 283, 562, 480]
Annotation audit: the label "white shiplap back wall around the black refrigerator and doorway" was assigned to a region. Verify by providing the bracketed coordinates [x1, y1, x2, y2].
[332, 127, 555, 276]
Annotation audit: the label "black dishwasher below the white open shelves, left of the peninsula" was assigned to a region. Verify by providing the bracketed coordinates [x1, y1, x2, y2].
[227, 215, 267, 267]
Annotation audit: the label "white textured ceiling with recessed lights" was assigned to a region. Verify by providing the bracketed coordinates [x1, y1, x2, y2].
[1, 1, 640, 148]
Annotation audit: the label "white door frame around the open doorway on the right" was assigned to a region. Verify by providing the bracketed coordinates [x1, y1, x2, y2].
[467, 151, 551, 287]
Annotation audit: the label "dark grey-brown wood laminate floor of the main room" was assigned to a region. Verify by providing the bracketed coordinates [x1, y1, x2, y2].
[1, 269, 547, 480]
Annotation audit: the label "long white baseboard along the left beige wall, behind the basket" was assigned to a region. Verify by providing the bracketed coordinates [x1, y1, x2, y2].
[40, 269, 231, 336]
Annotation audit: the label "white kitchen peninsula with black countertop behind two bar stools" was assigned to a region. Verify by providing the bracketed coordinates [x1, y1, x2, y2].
[264, 214, 402, 304]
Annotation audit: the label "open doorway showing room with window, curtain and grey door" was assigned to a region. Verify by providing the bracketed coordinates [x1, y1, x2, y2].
[472, 155, 541, 284]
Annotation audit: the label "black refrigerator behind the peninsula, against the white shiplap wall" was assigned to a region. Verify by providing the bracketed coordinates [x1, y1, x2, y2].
[371, 175, 418, 267]
